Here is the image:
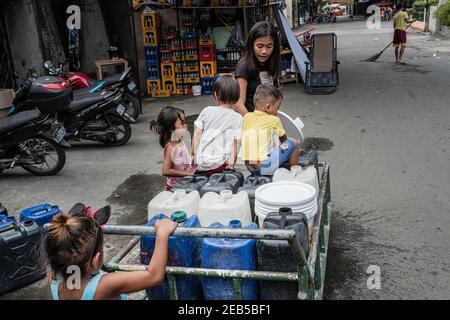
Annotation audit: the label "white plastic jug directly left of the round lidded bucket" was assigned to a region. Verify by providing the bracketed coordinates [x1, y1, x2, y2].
[198, 190, 253, 228]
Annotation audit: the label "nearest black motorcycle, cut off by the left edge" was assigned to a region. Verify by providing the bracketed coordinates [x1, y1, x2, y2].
[0, 110, 66, 176]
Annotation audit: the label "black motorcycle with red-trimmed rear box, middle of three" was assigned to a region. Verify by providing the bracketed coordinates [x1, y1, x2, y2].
[10, 68, 131, 146]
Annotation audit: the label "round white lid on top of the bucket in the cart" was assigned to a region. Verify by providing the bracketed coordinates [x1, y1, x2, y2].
[255, 181, 317, 207]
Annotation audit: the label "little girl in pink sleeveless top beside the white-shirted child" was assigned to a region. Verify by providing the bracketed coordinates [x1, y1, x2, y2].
[150, 107, 195, 191]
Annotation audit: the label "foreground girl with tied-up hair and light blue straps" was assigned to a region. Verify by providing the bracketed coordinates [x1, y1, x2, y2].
[45, 214, 177, 300]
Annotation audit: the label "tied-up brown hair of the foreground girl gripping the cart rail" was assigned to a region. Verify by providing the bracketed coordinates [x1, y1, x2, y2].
[45, 214, 103, 279]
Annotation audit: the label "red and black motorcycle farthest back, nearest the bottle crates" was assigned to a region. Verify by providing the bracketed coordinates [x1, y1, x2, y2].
[44, 61, 141, 120]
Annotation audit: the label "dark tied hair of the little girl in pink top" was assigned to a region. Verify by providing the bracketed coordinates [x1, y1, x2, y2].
[150, 107, 184, 148]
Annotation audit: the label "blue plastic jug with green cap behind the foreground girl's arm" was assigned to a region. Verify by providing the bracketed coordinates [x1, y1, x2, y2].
[141, 212, 200, 300]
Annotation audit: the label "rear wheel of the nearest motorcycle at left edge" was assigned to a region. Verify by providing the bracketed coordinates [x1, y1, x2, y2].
[20, 136, 66, 177]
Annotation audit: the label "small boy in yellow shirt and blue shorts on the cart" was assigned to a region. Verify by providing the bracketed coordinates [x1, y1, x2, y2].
[242, 84, 300, 176]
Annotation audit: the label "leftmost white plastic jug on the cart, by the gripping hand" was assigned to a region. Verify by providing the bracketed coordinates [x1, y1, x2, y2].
[148, 190, 200, 220]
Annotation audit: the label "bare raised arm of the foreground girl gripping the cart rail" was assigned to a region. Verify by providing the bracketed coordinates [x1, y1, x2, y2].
[95, 219, 178, 300]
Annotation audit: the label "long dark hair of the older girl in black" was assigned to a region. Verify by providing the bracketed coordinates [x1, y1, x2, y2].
[243, 21, 281, 79]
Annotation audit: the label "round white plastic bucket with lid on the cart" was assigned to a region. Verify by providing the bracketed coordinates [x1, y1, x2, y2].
[255, 181, 319, 230]
